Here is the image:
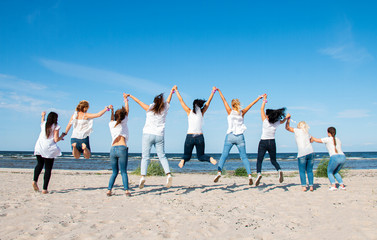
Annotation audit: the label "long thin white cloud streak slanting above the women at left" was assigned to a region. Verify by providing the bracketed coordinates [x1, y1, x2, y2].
[39, 59, 170, 94]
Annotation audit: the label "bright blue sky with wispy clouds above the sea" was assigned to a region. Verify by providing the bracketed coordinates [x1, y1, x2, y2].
[0, 0, 377, 153]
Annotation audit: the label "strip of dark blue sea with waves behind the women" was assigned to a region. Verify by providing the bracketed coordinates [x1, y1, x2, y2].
[0, 151, 377, 173]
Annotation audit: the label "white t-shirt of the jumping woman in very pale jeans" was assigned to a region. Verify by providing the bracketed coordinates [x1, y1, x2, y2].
[143, 102, 170, 136]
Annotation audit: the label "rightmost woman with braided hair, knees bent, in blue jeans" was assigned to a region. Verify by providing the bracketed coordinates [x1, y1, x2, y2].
[311, 127, 346, 191]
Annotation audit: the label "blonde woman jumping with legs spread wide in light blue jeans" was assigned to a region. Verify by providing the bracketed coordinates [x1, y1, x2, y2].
[214, 89, 261, 185]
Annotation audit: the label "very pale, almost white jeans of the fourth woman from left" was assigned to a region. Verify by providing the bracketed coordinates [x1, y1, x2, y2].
[141, 133, 170, 175]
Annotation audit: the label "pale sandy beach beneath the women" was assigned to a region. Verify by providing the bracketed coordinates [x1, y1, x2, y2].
[0, 169, 377, 240]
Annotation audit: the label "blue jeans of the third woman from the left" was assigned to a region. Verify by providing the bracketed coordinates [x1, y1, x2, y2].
[107, 146, 128, 190]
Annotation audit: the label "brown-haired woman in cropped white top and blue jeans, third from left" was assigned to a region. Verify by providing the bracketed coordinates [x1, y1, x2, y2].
[107, 93, 131, 197]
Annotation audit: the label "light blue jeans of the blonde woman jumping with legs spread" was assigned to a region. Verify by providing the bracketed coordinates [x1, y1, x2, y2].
[218, 133, 251, 174]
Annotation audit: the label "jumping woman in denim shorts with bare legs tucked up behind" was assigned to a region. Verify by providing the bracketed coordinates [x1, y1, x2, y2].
[63, 100, 111, 159]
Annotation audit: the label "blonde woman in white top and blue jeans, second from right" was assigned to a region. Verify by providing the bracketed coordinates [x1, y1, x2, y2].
[285, 116, 314, 192]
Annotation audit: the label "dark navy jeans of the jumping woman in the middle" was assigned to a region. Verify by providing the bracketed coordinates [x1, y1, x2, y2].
[183, 134, 210, 163]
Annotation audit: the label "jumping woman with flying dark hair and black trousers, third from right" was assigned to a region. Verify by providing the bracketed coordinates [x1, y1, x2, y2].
[255, 94, 290, 186]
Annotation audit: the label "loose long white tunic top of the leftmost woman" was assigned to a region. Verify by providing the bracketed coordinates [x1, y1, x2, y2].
[34, 121, 62, 158]
